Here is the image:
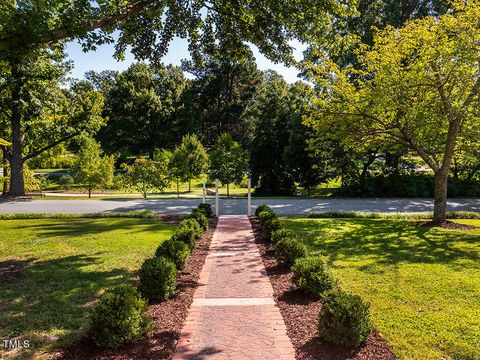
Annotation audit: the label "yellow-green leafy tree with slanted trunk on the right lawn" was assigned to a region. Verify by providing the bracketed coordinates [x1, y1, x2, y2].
[307, 1, 480, 224]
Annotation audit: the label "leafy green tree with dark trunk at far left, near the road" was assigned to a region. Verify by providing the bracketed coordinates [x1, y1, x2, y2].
[0, 51, 104, 196]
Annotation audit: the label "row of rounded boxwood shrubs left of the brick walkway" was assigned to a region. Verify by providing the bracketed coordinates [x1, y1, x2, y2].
[89, 204, 212, 348]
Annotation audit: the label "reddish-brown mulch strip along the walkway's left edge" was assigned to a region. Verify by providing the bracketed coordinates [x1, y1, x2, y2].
[49, 218, 217, 360]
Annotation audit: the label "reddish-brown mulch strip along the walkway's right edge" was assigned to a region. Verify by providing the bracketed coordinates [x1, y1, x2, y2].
[250, 217, 396, 360]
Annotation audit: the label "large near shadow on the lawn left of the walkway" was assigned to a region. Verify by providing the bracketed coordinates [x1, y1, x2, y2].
[0, 253, 132, 357]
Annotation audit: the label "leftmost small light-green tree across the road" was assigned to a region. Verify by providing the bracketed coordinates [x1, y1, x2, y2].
[73, 138, 115, 198]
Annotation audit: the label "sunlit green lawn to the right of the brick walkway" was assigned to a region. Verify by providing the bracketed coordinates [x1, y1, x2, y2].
[285, 219, 480, 360]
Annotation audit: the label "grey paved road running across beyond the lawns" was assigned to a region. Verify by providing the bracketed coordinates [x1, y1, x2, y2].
[0, 199, 480, 215]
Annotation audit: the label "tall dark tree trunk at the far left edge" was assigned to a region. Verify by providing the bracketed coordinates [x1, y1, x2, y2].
[8, 66, 25, 196]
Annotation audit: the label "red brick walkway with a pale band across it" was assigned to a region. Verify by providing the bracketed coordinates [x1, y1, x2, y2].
[173, 216, 295, 360]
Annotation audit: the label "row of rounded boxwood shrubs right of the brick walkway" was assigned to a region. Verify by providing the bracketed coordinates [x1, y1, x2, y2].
[255, 205, 372, 346]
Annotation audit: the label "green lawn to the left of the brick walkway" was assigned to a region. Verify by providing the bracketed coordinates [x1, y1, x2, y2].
[0, 218, 173, 358]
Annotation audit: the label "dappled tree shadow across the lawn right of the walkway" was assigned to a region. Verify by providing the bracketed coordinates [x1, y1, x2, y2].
[288, 219, 480, 267]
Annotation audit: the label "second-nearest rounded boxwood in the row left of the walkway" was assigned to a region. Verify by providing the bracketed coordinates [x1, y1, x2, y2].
[138, 257, 177, 301]
